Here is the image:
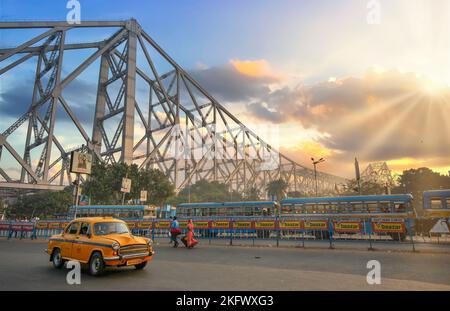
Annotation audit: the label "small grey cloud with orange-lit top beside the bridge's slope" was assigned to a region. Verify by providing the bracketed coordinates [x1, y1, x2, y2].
[190, 60, 281, 102]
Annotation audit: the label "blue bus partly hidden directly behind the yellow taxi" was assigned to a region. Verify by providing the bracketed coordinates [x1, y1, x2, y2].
[68, 205, 156, 220]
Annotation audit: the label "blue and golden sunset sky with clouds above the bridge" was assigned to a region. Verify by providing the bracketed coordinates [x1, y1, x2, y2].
[0, 0, 450, 177]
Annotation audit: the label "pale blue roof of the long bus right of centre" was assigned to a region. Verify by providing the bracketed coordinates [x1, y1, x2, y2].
[281, 194, 413, 205]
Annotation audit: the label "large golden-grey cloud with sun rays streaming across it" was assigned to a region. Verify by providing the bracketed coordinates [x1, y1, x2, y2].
[246, 70, 450, 172]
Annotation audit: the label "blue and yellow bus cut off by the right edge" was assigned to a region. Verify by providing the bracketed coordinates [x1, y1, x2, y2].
[423, 190, 450, 218]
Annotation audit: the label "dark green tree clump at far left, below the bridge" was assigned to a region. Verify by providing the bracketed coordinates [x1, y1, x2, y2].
[7, 189, 73, 218]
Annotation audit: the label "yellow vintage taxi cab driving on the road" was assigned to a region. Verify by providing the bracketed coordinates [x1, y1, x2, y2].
[46, 217, 154, 275]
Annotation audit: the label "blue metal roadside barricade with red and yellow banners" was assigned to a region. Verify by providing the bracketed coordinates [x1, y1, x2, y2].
[0, 214, 450, 254]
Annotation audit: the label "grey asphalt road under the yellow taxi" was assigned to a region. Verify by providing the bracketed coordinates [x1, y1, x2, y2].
[0, 239, 450, 291]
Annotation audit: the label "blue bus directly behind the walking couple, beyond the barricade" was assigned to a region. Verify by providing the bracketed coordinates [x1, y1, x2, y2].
[176, 201, 279, 218]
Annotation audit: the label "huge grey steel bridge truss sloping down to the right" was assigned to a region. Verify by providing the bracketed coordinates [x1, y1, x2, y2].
[0, 19, 344, 193]
